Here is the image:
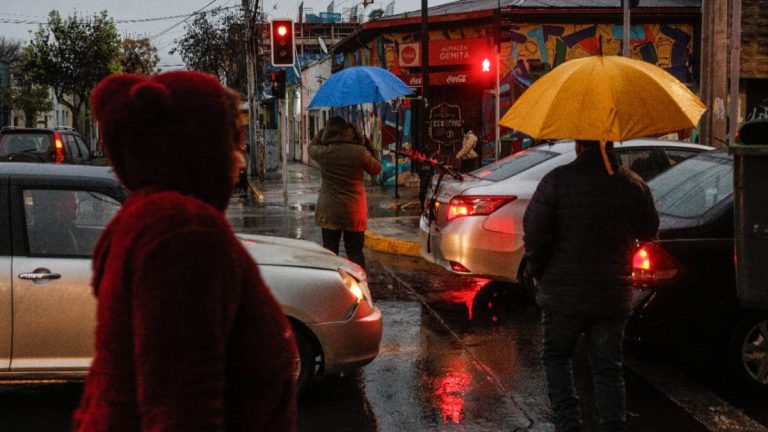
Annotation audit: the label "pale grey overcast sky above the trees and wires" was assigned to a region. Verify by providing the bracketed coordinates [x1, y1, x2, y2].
[0, 0, 452, 69]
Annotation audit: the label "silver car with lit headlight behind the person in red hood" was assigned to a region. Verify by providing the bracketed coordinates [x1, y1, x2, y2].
[0, 163, 382, 386]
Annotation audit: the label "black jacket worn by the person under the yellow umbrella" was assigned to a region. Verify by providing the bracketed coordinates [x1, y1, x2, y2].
[523, 148, 659, 317]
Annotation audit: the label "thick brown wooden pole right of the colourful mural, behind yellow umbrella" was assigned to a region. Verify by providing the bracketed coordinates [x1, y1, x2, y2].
[700, 0, 728, 147]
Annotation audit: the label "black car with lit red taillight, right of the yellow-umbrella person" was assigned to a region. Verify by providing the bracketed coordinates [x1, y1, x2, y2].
[626, 150, 768, 390]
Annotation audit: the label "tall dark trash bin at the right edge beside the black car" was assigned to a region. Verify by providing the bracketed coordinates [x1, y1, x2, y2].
[729, 119, 768, 310]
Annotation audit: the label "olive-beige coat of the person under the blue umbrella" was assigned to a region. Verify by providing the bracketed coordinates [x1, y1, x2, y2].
[309, 121, 381, 232]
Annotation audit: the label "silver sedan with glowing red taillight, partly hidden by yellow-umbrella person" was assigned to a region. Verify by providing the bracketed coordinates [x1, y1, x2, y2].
[419, 139, 711, 297]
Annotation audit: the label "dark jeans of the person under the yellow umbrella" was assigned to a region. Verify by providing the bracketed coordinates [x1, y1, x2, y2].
[542, 311, 627, 432]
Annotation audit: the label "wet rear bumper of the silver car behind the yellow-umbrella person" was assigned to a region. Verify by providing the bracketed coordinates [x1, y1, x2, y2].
[419, 216, 525, 282]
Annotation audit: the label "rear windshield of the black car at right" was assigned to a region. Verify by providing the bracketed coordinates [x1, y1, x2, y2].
[648, 152, 733, 219]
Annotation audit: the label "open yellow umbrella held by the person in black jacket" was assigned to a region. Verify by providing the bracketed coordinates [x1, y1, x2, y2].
[499, 56, 706, 172]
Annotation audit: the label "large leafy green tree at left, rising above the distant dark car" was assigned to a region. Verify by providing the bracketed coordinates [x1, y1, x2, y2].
[22, 10, 120, 130]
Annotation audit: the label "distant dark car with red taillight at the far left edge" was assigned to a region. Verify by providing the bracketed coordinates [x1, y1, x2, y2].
[0, 127, 94, 164]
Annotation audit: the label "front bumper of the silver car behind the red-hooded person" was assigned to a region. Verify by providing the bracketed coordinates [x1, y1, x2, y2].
[307, 303, 382, 375]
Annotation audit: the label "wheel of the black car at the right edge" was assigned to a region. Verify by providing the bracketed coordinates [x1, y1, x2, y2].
[729, 313, 768, 390]
